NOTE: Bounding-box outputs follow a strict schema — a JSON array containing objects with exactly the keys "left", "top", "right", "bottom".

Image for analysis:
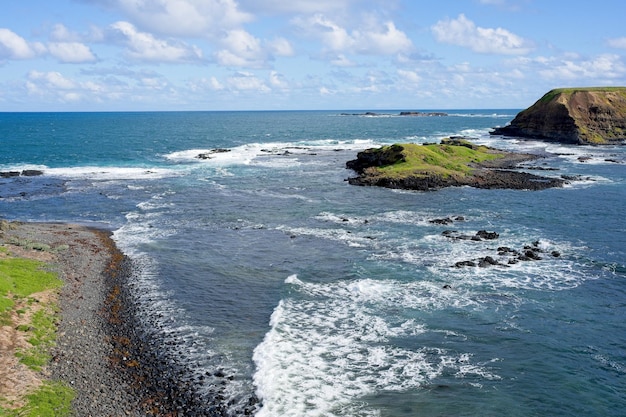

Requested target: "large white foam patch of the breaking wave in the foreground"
[{"left": 253, "top": 275, "right": 498, "bottom": 417}]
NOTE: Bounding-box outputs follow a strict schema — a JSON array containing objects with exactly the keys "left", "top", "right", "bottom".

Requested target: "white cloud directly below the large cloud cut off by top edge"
[{"left": 110, "top": 22, "right": 202, "bottom": 62}]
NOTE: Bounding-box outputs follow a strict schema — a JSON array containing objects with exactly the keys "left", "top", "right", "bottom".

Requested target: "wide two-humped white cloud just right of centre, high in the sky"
[{"left": 293, "top": 13, "right": 413, "bottom": 55}]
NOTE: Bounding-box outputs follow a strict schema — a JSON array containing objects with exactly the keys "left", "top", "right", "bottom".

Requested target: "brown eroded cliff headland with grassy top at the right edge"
[{"left": 492, "top": 87, "right": 626, "bottom": 144}]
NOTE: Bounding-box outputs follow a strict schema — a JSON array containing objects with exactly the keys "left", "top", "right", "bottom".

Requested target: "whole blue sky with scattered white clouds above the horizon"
[{"left": 0, "top": 0, "right": 626, "bottom": 111}]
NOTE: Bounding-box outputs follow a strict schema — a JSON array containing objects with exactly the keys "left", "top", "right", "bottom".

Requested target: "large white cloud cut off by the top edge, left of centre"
[{"left": 114, "top": 0, "right": 252, "bottom": 37}]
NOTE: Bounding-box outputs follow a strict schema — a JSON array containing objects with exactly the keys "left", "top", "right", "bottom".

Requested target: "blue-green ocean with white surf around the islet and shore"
[{"left": 0, "top": 109, "right": 626, "bottom": 417}]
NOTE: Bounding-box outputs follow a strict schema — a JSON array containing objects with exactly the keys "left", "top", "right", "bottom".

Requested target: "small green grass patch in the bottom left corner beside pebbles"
[{"left": 0, "top": 381, "right": 74, "bottom": 417}]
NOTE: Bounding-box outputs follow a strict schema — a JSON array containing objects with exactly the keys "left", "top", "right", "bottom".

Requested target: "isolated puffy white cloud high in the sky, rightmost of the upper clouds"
[{"left": 431, "top": 14, "right": 532, "bottom": 55}]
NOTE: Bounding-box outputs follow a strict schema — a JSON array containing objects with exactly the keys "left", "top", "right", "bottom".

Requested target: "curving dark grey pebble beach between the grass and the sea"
[{"left": 0, "top": 222, "right": 258, "bottom": 416}]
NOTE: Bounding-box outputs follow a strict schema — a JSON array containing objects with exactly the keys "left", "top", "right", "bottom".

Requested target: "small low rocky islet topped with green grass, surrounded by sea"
[{"left": 346, "top": 138, "right": 564, "bottom": 191}]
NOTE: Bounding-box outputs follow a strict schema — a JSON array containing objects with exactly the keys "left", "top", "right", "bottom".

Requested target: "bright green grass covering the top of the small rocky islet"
[{"left": 370, "top": 140, "right": 502, "bottom": 178}]
